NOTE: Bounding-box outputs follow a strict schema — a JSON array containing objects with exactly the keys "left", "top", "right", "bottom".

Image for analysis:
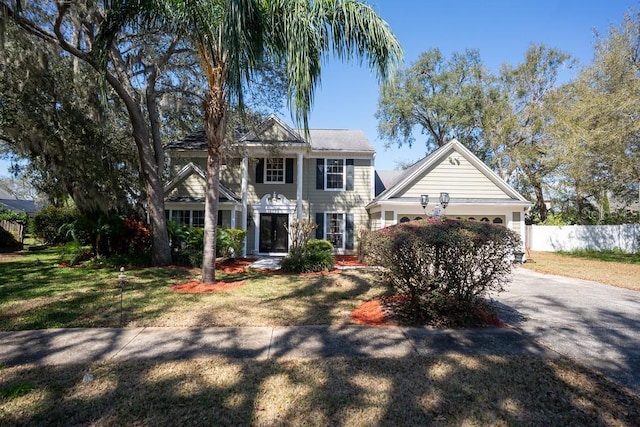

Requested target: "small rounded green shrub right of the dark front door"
[{"left": 280, "top": 239, "right": 335, "bottom": 273}]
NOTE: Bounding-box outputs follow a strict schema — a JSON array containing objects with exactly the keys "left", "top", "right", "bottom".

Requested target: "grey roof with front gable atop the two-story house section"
[{"left": 165, "top": 114, "right": 375, "bottom": 153}]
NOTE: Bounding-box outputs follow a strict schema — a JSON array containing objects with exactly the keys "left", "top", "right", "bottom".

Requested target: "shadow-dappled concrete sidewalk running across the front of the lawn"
[{"left": 0, "top": 325, "right": 555, "bottom": 365}]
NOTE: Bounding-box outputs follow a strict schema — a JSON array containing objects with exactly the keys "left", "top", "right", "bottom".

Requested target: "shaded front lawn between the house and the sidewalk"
[{"left": 0, "top": 250, "right": 387, "bottom": 330}]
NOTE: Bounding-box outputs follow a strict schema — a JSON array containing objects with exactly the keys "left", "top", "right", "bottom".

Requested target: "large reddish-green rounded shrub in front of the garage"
[{"left": 364, "top": 219, "right": 519, "bottom": 324}]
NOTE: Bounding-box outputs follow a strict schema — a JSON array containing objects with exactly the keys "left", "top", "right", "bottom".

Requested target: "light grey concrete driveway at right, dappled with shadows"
[{"left": 494, "top": 268, "right": 640, "bottom": 392}]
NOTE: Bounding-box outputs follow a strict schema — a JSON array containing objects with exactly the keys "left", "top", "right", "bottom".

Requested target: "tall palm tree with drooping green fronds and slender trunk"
[{"left": 99, "top": 0, "right": 402, "bottom": 283}]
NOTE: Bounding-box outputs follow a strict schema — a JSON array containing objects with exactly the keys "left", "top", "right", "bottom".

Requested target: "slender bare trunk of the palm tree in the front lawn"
[{"left": 202, "top": 86, "right": 227, "bottom": 283}]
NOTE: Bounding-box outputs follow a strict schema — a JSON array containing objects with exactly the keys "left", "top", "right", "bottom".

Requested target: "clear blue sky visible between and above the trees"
[{"left": 0, "top": 0, "right": 640, "bottom": 175}]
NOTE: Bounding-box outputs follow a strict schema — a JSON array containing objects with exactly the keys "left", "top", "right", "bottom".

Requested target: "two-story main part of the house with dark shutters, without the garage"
[{"left": 165, "top": 116, "right": 375, "bottom": 255}]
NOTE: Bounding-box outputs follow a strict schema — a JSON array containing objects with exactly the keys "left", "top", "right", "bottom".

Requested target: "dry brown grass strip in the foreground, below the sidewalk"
[{"left": 0, "top": 354, "right": 640, "bottom": 426}]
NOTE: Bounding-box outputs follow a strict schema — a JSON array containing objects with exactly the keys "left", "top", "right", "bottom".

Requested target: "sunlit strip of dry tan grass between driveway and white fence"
[{"left": 523, "top": 252, "right": 640, "bottom": 291}]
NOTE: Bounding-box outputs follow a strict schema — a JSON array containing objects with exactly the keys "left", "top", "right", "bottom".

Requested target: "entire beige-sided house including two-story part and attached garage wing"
[{"left": 165, "top": 115, "right": 530, "bottom": 255}]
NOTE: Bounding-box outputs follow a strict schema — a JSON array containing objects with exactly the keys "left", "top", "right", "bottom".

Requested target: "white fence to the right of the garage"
[{"left": 526, "top": 224, "right": 640, "bottom": 253}]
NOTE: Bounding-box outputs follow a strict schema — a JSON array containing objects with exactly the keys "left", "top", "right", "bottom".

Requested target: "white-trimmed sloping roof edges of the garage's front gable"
[{"left": 368, "top": 139, "right": 529, "bottom": 206}]
